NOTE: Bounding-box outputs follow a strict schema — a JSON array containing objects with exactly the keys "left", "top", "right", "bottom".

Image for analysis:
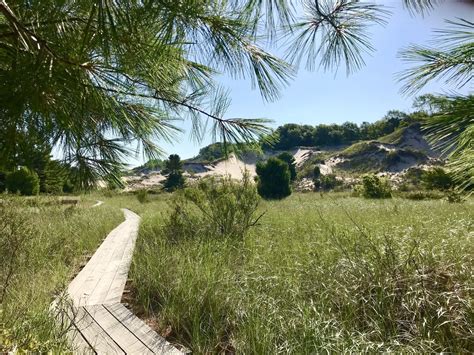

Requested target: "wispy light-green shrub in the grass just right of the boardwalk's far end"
[{"left": 164, "top": 174, "right": 260, "bottom": 241}]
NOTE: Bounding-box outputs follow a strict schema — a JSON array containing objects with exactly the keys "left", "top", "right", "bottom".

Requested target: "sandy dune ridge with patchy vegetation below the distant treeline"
[{"left": 126, "top": 124, "right": 441, "bottom": 190}]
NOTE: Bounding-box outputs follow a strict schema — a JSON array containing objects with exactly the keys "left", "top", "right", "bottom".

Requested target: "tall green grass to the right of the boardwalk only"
[{"left": 131, "top": 194, "right": 474, "bottom": 354}]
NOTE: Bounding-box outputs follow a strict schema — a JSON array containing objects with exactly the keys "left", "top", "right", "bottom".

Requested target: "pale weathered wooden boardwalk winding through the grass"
[{"left": 66, "top": 209, "right": 182, "bottom": 354}]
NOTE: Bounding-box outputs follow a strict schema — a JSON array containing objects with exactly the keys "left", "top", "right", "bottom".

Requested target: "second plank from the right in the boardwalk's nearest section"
[{"left": 85, "top": 305, "right": 153, "bottom": 354}]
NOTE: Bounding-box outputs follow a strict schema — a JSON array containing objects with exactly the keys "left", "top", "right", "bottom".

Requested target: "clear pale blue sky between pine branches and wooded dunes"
[{"left": 130, "top": 0, "right": 474, "bottom": 165}]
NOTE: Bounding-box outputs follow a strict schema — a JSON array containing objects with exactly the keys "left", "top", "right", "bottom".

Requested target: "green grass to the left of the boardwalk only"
[{"left": 0, "top": 196, "right": 123, "bottom": 352}]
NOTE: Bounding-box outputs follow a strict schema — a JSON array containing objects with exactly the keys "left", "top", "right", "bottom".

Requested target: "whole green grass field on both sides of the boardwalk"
[{"left": 0, "top": 193, "right": 474, "bottom": 354}]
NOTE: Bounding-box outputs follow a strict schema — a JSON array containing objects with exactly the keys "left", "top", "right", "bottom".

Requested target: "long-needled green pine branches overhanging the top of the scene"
[{"left": 0, "top": 0, "right": 473, "bottom": 187}]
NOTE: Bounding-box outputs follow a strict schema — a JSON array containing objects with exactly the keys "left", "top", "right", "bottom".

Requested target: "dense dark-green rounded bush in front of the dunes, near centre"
[{"left": 257, "top": 158, "right": 291, "bottom": 199}]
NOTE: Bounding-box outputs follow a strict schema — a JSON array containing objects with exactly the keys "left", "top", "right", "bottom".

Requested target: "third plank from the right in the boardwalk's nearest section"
[{"left": 73, "top": 307, "right": 125, "bottom": 354}]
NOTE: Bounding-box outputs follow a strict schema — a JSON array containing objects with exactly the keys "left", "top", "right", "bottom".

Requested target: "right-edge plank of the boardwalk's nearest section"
[{"left": 104, "top": 303, "right": 183, "bottom": 355}]
